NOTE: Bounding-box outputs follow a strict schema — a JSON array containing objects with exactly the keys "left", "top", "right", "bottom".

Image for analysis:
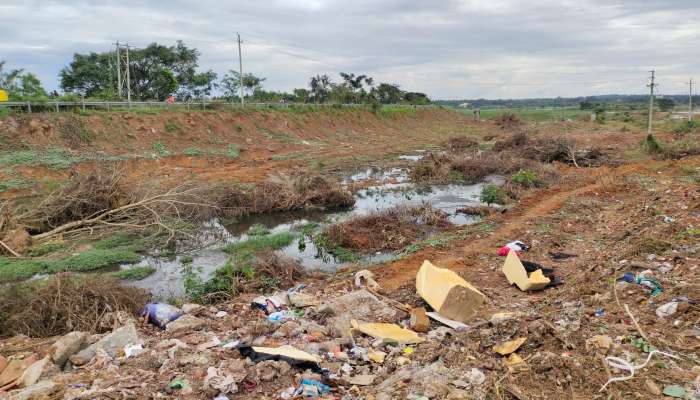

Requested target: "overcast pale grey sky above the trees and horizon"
[{"left": 0, "top": 0, "right": 700, "bottom": 99}]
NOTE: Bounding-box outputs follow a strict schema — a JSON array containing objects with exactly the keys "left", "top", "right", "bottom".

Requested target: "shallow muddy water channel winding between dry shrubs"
[{"left": 120, "top": 159, "right": 501, "bottom": 299}]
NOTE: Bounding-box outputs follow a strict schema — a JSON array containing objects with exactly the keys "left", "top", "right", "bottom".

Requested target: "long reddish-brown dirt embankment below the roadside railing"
[{"left": 0, "top": 108, "right": 466, "bottom": 197}]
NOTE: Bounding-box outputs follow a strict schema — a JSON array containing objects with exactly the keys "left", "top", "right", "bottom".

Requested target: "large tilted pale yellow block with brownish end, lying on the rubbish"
[{"left": 416, "top": 260, "right": 486, "bottom": 322}]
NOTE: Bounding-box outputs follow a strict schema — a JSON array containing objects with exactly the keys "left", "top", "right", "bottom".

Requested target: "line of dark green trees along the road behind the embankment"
[{"left": 0, "top": 41, "right": 430, "bottom": 104}]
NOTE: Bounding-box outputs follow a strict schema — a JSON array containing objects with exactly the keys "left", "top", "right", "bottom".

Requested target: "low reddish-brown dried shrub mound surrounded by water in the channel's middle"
[{"left": 326, "top": 204, "right": 450, "bottom": 253}]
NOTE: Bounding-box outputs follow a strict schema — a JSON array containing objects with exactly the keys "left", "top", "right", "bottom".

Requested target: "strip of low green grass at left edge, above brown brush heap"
[{"left": 0, "top": 235, "right": 145, "bottom": 283}]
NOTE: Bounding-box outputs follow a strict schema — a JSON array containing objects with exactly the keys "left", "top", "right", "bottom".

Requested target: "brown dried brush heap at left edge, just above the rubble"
[{"left": 0, "top": 274, "right": 148, "bottom": 337}]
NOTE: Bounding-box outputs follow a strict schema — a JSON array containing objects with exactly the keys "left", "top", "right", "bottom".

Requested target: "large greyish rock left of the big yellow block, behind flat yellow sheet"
[{"left": 325, "top": 290, "right": 406, "bottom": 336}]
